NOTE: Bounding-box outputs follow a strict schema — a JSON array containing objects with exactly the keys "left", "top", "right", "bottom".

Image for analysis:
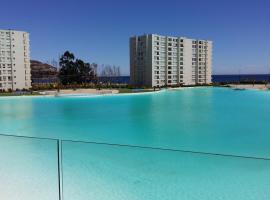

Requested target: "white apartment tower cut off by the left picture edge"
[{"left": 0, "top": 30, "right": 31, "bottom": 90}]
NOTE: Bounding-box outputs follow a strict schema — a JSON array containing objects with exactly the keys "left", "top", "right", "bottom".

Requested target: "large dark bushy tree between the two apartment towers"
[{"left": 59, "top": 51, "right": 96, "bottom": 85}]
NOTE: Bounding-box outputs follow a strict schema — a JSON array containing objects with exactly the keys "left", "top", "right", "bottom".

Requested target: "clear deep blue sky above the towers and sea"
[{"left": 0, "top": 0, "right": 270, "bottom": 74}]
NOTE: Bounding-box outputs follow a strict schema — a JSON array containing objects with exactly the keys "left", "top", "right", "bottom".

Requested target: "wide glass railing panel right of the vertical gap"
[{"left": 62, "top": 142, "right": 270, "bottom": 200}]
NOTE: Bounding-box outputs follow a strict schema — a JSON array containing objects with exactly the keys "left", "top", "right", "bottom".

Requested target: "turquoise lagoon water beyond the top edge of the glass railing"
[{"left": 0, "top": 88, "right": 270, "bottom": 158}]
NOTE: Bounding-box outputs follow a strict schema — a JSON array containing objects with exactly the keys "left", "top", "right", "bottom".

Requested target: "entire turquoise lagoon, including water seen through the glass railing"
[{"left": 0, "top": 88, "right": 270, "bottom": 200}]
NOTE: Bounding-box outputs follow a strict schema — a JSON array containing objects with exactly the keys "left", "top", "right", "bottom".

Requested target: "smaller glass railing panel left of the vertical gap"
[{"left": 0, "top": 136, "right": 59, "bottom": 200}]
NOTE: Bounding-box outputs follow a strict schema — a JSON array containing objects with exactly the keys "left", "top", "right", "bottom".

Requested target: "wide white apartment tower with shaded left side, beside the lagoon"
[{"left": 130, "top": 34, "right": 212, "bottom": 87}]
